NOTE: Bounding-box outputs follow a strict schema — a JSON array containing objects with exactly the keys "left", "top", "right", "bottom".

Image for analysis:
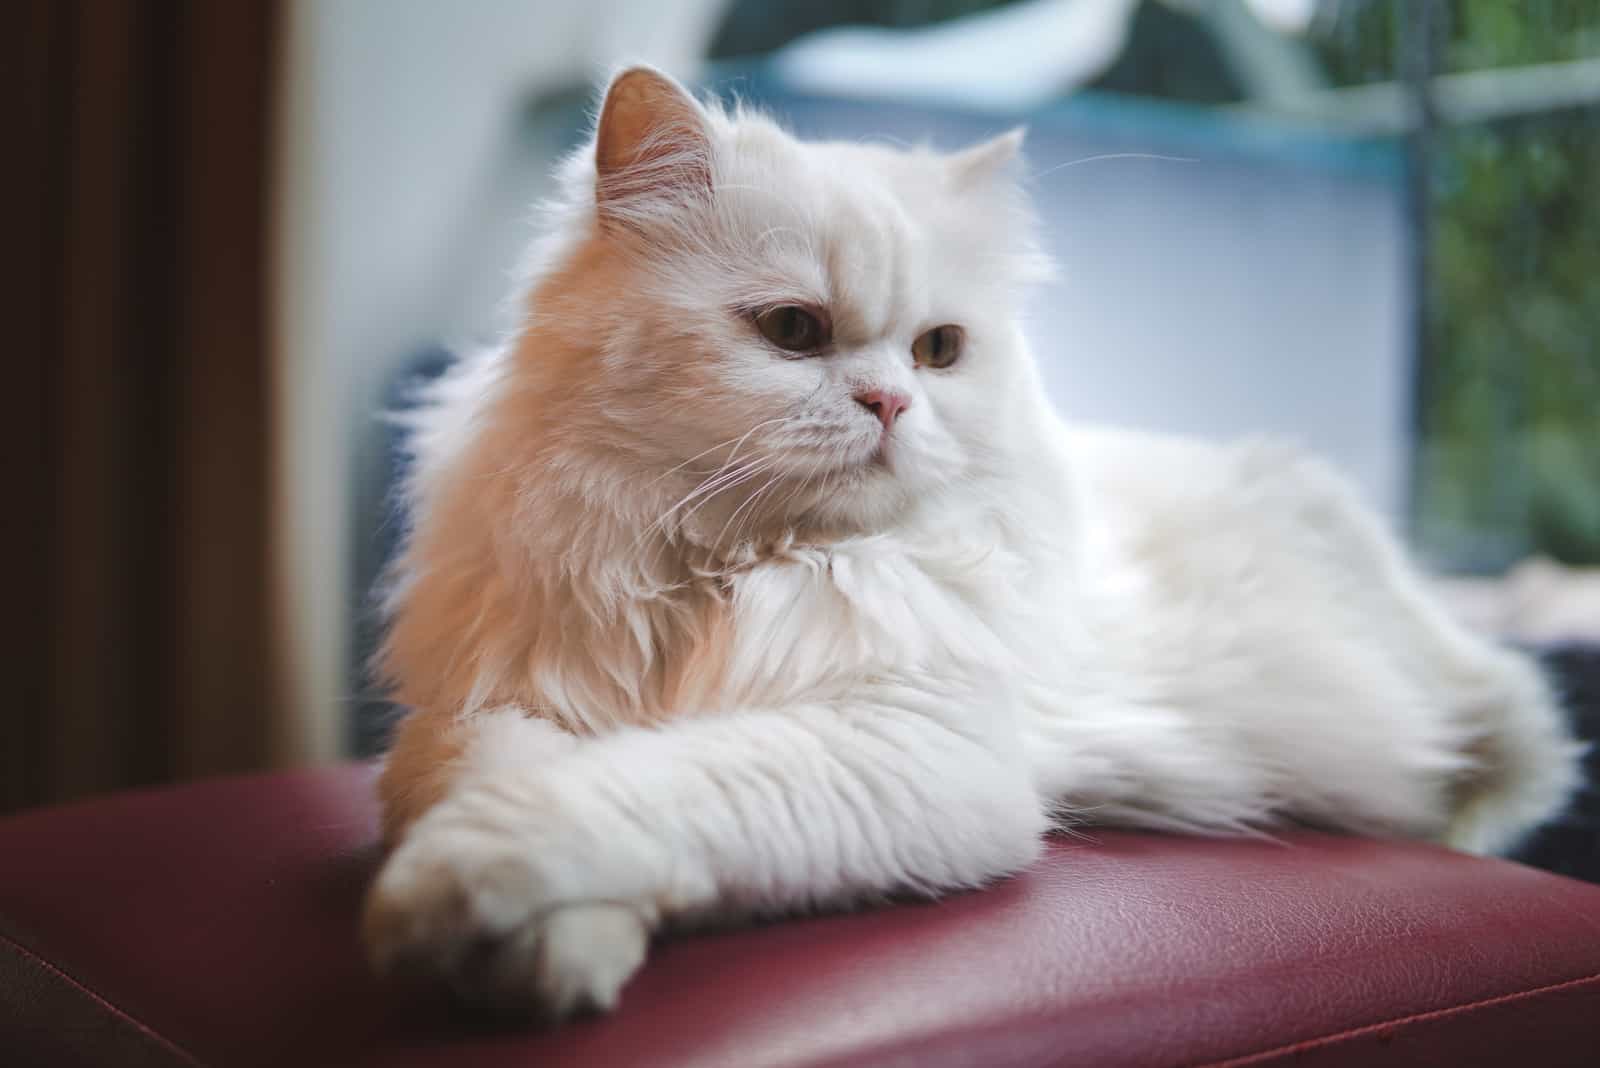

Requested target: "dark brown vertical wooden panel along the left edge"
[{"left": 0, "top": 0, "right": 278, "bottom": 807}]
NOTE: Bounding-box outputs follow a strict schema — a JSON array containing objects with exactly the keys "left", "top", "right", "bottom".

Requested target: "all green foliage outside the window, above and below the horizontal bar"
[{"left": 1317, "top": 0, "right": 1600, "bottom": 569}]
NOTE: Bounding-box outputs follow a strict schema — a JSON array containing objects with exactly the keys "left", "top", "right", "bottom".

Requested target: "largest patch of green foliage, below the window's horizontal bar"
[{"left": 1418, "top": 114, "right": 1600, "bottom": 566}]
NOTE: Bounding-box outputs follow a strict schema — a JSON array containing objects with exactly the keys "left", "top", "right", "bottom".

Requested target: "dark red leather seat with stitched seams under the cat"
[{"left": 0, "top": 767, "right": 1600, "bottom": 1068}]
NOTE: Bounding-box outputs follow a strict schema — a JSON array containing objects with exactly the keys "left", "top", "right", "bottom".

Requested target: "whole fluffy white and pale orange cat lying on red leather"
[{"left": 363, "top": 67, "right": 1579, "bottom": 1017}]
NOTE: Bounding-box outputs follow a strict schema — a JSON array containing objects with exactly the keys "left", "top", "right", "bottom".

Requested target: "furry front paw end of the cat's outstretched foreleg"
[{"left": 363, "top": 803, "right": 654, "bottom": 1018}]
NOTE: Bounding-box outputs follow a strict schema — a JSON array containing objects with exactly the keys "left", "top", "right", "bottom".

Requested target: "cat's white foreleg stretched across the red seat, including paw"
[{"left": 365, "top": 683, "right": 1046, "bottom": 1014}]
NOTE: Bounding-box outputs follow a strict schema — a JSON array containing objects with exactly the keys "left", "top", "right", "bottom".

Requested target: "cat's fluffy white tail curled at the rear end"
[{"left": 1443, "top": 649, "right": 1587, "bottom": 854}]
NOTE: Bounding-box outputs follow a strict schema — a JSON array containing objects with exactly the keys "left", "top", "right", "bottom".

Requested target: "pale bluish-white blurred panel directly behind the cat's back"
[{"left": 1030, "top": 136, "right": 1413, "bottom": 521}]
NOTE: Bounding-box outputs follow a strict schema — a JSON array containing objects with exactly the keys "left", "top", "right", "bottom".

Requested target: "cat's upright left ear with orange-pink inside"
[{"left": 595, "top": 67, "right": 710, "bottom": 214}]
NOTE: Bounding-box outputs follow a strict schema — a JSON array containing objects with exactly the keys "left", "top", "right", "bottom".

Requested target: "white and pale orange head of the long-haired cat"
[{"left": 523, "top": 67, "right": 1048, "bottom": 542}]
